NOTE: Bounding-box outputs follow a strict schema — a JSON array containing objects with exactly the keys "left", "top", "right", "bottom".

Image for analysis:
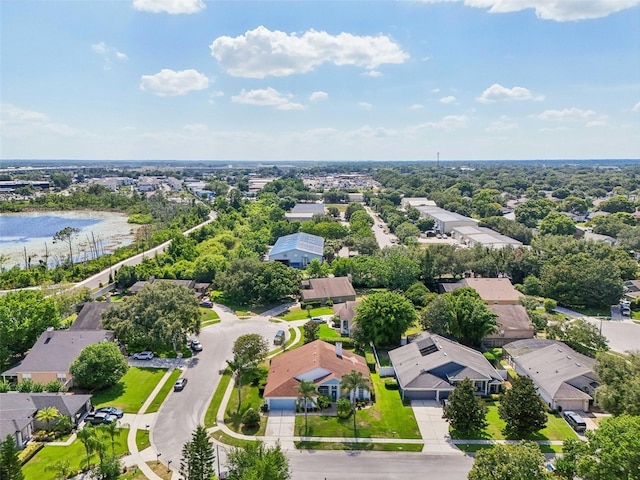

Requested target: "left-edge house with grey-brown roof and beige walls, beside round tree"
[{"left": 2, "top": 328, "right": 114, "bottom": 387}]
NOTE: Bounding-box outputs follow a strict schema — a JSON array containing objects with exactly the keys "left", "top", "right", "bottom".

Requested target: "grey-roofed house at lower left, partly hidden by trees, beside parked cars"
[{"left": 0, "top": 392, "right": 91, "bottom": 448}]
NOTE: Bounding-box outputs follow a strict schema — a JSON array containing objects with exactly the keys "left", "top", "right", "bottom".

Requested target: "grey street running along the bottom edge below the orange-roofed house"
[{"left": 288, "top": 451, "right": 473, "bottom": 480}]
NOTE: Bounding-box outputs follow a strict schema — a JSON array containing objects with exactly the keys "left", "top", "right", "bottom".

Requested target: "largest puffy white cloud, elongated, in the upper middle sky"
[{"left": 209, "top": 26, "right": 409, "bottom": 78}]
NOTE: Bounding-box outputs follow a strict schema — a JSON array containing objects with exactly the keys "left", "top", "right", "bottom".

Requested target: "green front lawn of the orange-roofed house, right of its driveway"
[{"left": 295, "top": 374, "right": 420, "bottom": 438}]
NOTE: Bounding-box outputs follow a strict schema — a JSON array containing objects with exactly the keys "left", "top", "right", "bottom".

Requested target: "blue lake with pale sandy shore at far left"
[{"left": 0, "top": 210, "right": 139, "bottom": 268}]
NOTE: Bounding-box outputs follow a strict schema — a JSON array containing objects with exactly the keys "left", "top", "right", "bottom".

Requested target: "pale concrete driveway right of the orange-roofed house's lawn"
[{"left": 411, "top": 400, "right": 462, "bottom": 455}]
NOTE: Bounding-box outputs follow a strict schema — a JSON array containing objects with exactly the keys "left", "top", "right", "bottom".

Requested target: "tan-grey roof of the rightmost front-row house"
[{"left": 504, "top": 339, "right": 598, "bottom": 400}]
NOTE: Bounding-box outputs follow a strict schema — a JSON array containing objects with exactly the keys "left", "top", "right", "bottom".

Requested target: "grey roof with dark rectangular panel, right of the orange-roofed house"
[{"left": 389, "top": 333, "right": 502, "bottom": 389}]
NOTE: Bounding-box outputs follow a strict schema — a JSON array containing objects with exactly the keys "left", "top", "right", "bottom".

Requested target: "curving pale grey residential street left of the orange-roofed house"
[{"left": 151, "top": 317, "right": 283, "bottom": 469}]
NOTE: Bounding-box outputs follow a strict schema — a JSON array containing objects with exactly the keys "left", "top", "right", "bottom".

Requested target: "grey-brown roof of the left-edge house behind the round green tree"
[{"left": 2, "top": 330, "right": 113, "bottom": 376}]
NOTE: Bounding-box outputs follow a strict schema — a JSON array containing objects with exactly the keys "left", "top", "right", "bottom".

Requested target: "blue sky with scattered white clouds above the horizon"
[{"left": 0, "top": 0, "right": 640, "bottom": 161}]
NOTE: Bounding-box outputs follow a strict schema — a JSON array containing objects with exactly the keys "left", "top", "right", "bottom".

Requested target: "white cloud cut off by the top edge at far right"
[{"left": 412, "top": 0, "right": 640, "bottom": 22}]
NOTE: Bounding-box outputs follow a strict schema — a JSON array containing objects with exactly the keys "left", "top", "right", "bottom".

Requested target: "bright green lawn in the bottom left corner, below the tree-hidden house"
[{"left": 22, "top": 428, "right": 129, "bottom": 480}]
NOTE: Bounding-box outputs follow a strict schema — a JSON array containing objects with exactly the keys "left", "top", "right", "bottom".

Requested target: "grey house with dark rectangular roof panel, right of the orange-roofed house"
[{"left": 389, "top": 332, "right": 503, "bottom": 401}]
